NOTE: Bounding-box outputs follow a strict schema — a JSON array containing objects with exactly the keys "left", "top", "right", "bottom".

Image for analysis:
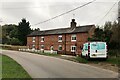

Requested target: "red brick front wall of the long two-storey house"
[{"left": 27, "top": 33, "right": 89, "bottom": 54}]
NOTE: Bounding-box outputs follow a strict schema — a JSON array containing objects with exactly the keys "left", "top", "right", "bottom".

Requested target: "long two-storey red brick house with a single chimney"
[{"left": 27, "top": 19, "right": 95, "bottom": 55}]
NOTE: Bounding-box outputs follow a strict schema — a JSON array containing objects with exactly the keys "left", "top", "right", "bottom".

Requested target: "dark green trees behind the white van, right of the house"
[{"left": 88, "top": 22, "right": 120, "bottom": 49}]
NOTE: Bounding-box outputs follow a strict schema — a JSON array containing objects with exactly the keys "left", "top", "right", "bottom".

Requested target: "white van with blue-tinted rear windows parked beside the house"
[{"left": 81, "top": 42, "right": 108, "bottom": 59}]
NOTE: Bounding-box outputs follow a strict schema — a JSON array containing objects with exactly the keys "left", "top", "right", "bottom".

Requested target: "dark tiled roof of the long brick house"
[{"left": 28, "top": 25, "right": 94, "bottom": 36}]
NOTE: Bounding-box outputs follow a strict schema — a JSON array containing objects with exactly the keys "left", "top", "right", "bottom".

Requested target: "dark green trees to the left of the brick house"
[{"left": 2, "top": 19, "right": 32, "bottom": 45}]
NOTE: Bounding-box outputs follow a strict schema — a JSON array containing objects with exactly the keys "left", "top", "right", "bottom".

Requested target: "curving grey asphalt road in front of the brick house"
[{"left": 2, "top": 50, "right": 118, "bottom": 78}]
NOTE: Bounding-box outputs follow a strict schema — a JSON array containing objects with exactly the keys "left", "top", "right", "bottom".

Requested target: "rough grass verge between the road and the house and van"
[{"left": 29, "top": 51, "right": 120, "bottom": 72}]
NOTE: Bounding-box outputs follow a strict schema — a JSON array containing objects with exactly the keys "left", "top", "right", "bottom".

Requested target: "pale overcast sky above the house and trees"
[{"left": 0, "top": 0, "right": 118, "bottom": 30}]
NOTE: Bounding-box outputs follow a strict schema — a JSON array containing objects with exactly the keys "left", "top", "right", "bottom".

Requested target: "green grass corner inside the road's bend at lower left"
[{"left": 2, "top": 55, "right": 32, "bottom": 80}]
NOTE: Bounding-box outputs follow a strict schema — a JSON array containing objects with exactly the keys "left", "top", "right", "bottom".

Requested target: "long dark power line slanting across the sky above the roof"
[{"left": 32, "top": 0, "right": 96, "bottom": 26}]
